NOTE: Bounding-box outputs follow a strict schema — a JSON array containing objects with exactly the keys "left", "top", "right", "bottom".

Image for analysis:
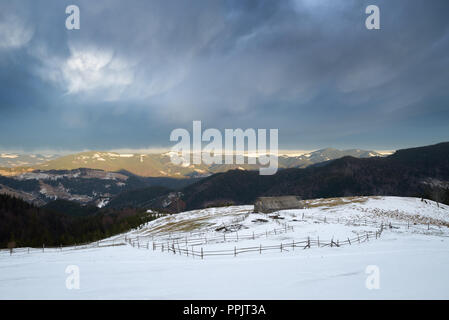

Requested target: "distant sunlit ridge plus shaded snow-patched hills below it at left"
[{"left": 0, "top": 148, "right": 380, "bottom": 207}]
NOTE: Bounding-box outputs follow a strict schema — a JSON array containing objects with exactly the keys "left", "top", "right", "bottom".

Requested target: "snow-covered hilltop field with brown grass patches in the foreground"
[{"left": 0, "top": 197, "right": 449, "bottom": 299}]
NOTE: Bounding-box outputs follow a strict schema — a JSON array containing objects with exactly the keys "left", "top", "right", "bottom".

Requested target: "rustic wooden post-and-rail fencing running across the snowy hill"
[{"left": 5, "top": 215, "right": 448, "bottom": 257}]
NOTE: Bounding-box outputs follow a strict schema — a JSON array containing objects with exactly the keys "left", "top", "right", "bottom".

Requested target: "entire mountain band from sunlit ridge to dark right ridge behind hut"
[{"left": 0, "top": 143, "right": 449, "bottom": 212}]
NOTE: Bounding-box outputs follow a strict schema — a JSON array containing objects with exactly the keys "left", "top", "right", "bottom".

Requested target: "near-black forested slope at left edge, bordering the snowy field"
[{"left": 0, "top": 195, "right": 158, "bottom": 248}]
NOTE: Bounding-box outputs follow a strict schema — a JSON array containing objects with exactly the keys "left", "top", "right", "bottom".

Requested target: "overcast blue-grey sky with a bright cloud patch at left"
[{"left": 0, "top": 0, "right": 449, "bottom": 152}]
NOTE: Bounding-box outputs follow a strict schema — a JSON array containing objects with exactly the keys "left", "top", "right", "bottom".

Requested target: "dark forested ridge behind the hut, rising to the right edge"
[{"left": 178, "top": 142, "right": 449, "bottom": 210}]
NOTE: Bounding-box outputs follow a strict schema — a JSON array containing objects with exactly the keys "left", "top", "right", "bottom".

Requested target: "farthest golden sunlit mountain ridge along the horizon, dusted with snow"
[{"left": 0, "top": 148, "right": 382, "bottom": 178}]
